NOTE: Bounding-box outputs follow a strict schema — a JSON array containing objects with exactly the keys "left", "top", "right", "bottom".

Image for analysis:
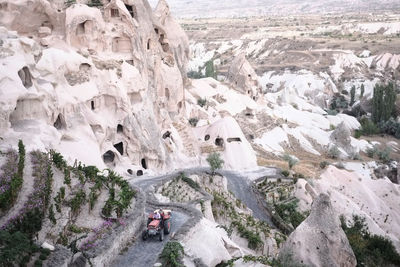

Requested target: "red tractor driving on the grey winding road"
[{"left": 142, "top": 210, "right": 171, "bottom": 241}]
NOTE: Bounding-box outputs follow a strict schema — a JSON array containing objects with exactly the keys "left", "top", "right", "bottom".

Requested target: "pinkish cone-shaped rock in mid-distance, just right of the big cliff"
[{"left": 228, "top": 53, "right": 261, "bottom": 100}]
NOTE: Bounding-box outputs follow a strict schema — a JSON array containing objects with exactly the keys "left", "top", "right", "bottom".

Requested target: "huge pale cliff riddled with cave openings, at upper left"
[{"left": 0, "top": 0, "right": 189, "bottom": 172}]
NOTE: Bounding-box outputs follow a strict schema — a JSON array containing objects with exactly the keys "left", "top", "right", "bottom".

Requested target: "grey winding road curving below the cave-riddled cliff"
[{"left": 113, "top": 167, "right": 278, "bottom": 267}]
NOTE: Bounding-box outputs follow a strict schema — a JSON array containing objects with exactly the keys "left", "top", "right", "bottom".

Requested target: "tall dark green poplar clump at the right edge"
[{"left": 372, "top": 83, "right": 396, "bottom": 123}]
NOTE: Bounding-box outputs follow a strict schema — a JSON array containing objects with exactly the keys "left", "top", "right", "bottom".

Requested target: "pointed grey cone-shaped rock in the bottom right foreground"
[{"left": 279, "top": 194, "right": 357, "bottom": 267}]
